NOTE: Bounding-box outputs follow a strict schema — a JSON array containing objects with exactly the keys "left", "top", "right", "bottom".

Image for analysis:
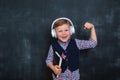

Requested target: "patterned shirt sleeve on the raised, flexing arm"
[{"left": 75, "top": 38, "right": 97, "bottom": 50}]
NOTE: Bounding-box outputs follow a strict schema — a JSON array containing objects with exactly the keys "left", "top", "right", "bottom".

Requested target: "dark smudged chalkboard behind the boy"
[{"left": 0, "top": 0, "right": 120, "bottom": 80}]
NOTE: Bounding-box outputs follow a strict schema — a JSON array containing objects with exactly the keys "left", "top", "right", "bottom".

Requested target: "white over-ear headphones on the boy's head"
[{"left": 51, "top": 17, "right": 75, "bottom": 38}]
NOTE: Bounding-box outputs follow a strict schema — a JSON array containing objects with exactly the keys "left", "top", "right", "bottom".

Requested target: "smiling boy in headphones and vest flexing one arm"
[{"left": 46, "top": 17, "right": 97, "bottom": 80}]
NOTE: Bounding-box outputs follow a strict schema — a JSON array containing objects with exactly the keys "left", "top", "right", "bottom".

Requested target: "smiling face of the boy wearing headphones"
[{"left": 55, "top": 24, "right": 71, "bottom": 42}]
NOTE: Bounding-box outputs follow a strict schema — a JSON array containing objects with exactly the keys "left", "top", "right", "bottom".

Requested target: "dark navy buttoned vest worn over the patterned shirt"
[{"left": 52, "top": 39, "right": 79, "bottom": 72}]
